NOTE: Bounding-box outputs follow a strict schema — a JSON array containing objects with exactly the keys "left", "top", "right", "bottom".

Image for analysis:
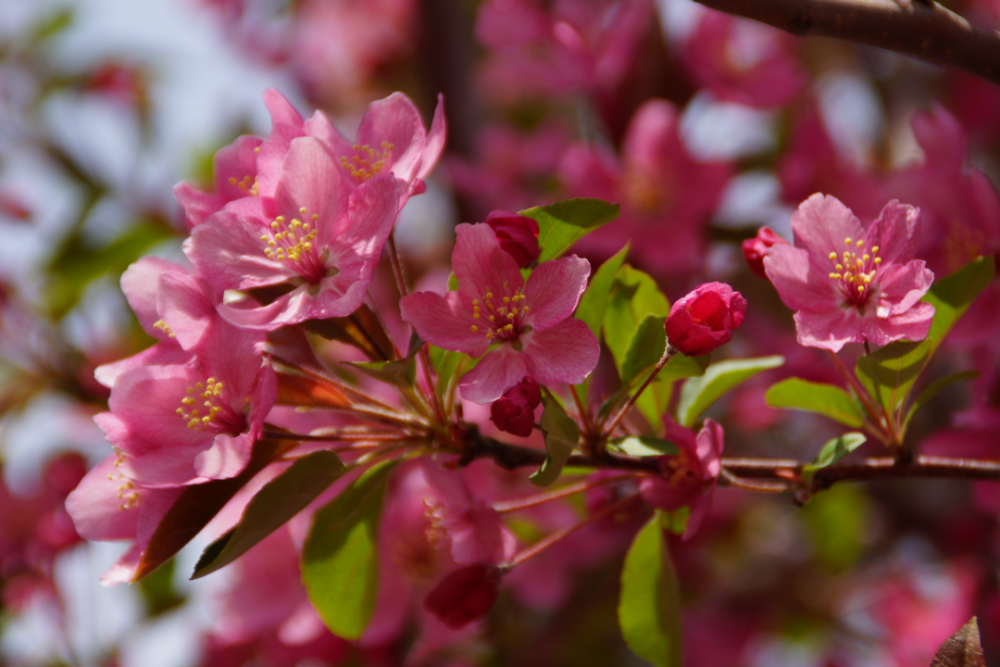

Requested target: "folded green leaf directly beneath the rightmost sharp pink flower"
[{"left": 854, "top": 338, "right": 935, "bottom": 414}]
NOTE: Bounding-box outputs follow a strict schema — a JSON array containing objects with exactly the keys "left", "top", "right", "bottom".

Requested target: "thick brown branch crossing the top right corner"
[{"left": 697, "top": 0, "right": 1000, "bottom": 84}]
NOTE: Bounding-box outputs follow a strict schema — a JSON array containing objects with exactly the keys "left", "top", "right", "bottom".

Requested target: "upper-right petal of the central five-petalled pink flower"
[{"left": 524, "top": 255, "right": 590, "bottom": 330}]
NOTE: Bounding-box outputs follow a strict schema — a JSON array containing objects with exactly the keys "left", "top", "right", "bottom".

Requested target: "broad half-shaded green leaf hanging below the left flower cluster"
[{"left": 302, "top": 461, "right": 397, "bottom": 639}]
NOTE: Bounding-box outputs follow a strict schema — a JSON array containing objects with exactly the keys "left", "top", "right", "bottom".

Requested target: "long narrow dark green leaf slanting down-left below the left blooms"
[{"left": 191, "top": 450, "right": 344, "bottom": 579}]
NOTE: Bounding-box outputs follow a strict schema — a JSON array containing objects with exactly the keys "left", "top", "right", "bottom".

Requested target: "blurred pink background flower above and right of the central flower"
[{"left": 559, "top": 100, "right": 732, "bottom": 275}]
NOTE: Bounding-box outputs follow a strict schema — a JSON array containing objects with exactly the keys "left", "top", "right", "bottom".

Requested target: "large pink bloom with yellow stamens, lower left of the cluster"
[{"left": 94, "top": 320, "right": 277, "bottom": 487}]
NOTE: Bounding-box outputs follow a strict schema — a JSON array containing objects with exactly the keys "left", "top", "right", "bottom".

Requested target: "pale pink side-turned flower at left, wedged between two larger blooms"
[{"left": 94, "top": 257, "right": 217, "bottom": 388}]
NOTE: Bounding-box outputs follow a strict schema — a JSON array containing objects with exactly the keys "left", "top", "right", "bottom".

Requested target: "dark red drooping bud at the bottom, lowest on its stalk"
[{"left": 424, "top": 565, "right": 500, "bottom": 630}]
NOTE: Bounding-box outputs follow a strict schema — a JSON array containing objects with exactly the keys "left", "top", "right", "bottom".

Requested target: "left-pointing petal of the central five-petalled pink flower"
[{"left": 399, "top": 292, "right": 490, "bottom": 358}]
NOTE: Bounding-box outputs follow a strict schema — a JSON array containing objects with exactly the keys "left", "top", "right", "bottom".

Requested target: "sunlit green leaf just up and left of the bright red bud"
[{"left": 602, "top": 264, "right": 670, "bottom": 374}]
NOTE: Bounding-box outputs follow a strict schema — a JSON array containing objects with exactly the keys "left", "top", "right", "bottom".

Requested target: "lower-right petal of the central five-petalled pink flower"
[{"left": 520, "top": 318, "right": 601, "bottom": 386}]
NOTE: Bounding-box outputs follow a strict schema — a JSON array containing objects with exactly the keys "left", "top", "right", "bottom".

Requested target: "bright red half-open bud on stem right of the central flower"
[{"left": 666, "top": 283, "right": 747, "bottom": 357}]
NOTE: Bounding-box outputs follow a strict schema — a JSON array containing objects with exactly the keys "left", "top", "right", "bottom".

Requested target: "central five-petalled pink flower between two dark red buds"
[{"left": 399, "top": 223, "right": 600, "bottom": 404}]
